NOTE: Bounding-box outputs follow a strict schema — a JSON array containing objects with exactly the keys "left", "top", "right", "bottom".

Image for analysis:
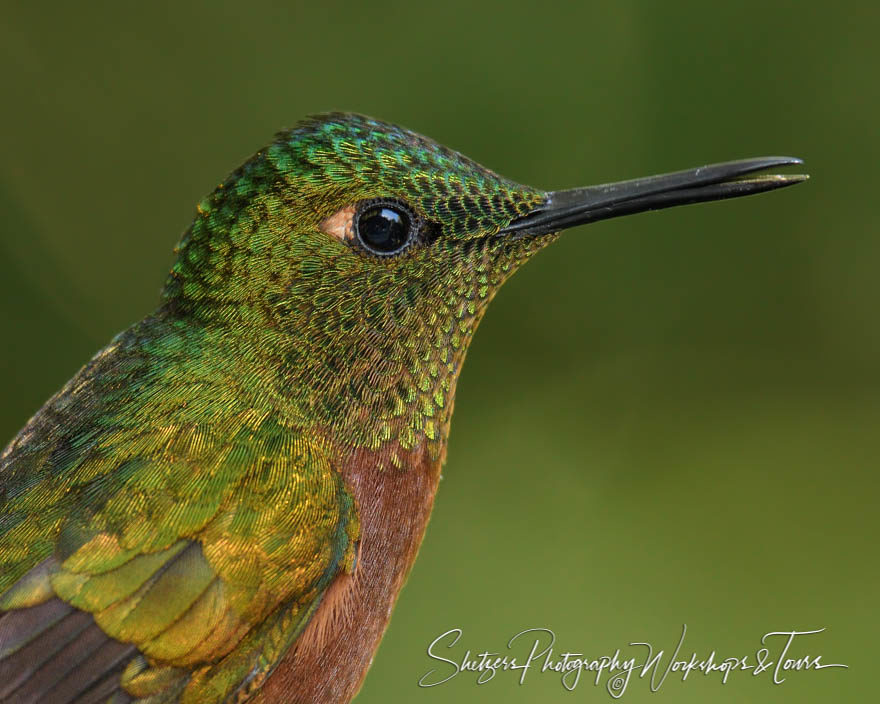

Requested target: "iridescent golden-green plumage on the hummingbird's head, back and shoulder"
[{"left": 0, "top": 115, "right": 552, "bottom": 704}]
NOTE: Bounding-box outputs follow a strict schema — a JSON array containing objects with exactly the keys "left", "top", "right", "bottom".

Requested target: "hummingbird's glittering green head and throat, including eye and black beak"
[{"left": 163, "top": 113, "right": 802, "bottom": 464}]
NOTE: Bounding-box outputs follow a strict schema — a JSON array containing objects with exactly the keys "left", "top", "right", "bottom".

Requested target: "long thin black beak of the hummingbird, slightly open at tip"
[{"left": 501, "top": 156, "right": 808, "bottom": 237}]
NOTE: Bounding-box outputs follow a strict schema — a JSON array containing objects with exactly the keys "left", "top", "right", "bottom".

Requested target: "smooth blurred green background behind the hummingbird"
[{"left": 0, "top": 0, "right": 880, "bottom": 704}]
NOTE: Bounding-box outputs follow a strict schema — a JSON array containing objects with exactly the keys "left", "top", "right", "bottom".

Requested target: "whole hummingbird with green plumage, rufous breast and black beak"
[{"left": 0, "top": 113, "right": 806, "bottom": 704}]
